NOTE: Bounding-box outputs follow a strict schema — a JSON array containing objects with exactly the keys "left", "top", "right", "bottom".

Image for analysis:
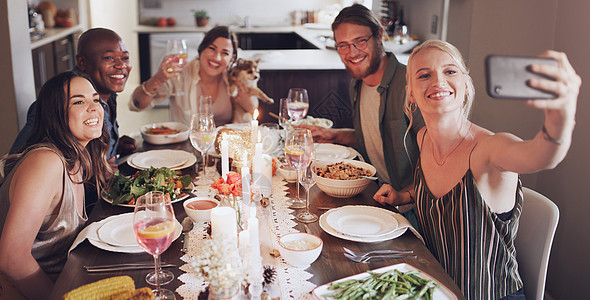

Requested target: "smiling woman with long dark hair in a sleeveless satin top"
[{"left": 0, "top": 72, "right": 110, "bottom": 299}]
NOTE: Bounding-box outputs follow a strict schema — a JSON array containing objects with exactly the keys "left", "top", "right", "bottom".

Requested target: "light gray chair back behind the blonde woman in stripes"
[{"left": 515, "top": 187, "right": 559, "bottom": 300}]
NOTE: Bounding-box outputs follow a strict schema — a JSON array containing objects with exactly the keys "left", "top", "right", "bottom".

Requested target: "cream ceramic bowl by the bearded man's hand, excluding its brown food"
[{"left": 316, "top": 159, "right": 377, "bottom": 198}]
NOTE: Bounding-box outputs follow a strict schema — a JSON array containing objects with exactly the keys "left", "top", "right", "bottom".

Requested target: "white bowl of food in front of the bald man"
[{"left": 139, "top": 122, "right": 190, "bottom": 145}]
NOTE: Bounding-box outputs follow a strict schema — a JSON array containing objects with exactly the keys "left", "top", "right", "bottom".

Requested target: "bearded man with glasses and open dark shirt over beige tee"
[{"left": 306, "top": 4, "right": 424, "bottom": 224}]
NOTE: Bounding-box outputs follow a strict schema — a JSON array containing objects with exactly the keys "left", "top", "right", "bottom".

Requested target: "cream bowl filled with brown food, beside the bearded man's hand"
[{"left": 316, "top": 159, "right": 377, "bottom": 198}]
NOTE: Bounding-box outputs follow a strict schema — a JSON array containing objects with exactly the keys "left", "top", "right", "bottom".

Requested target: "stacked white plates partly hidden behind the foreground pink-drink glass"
[{"left": 88, "top": 213, "right": 182, "bottom": 253}]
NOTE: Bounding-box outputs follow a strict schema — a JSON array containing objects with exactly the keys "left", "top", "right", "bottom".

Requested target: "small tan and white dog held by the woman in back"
[{"left": 228, "top": 58, "right": 274, "bottom": 123}]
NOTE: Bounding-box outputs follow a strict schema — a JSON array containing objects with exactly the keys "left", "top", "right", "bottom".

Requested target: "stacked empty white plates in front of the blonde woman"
[{"left": 320, "top": 205, "right": 407, "bottom": 243}]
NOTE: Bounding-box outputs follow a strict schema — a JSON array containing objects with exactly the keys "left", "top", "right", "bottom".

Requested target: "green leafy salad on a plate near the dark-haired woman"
[{"left": 103, "top": 167, "right": 192, "bottom": 205}]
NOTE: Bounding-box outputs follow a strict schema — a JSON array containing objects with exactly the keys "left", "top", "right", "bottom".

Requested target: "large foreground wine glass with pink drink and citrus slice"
[{"left": 133, "top": 191, "right": 176, "bottom": 299}]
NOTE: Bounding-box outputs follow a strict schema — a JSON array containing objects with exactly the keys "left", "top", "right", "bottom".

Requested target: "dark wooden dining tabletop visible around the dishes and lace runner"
[{"left": 49, "top": 141, "right": 464, "bottom": 299}]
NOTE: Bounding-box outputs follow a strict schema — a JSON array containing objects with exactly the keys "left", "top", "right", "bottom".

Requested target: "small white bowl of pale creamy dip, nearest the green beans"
[{"left": 279, "top": 232, "right": 324, "bottom": 268}]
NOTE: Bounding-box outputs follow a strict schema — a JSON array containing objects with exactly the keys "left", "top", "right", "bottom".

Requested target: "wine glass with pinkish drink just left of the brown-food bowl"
[{"left": 285, "top": 128, "right": 313, "bottom": 208}]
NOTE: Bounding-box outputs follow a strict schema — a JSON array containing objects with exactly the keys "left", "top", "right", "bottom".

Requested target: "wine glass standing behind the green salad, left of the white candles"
[{"left": 190, "top": 113, "right": 216, "bottom": 180}]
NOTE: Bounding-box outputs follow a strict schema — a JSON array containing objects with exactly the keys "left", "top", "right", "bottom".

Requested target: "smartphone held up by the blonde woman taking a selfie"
[{"left": 485, "top": 55, "right": 557, "bottom": 99}]
